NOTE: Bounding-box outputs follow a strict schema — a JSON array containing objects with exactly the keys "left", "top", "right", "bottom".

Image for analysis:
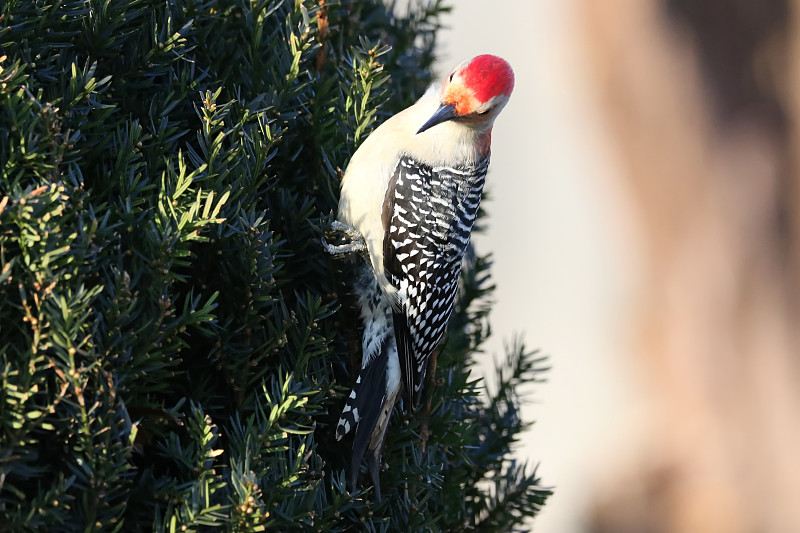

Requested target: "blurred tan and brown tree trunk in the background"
[{"left": 582, "top": 0, "right": 800, "bottom": 533}]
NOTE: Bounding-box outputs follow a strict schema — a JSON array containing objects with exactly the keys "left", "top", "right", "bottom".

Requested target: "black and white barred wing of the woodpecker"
[{"left": 383, "top": 156, "right": 489, "bottom": 409}]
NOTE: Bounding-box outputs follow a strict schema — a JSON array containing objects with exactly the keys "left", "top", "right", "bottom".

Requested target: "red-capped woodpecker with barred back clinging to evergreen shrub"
[{"left": 325, "top": 55, "right": 514, "bottom": 499}]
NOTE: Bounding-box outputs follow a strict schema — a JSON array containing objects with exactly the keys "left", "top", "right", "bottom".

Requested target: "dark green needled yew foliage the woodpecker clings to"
[{"left": 0, "top": 0, "right": 548, "bottom": 531}]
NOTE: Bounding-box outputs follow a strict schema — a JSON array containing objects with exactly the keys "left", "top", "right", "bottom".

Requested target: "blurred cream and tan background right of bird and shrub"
[{"left": 439, "top": 0, "right": 800, "bottom": 533}]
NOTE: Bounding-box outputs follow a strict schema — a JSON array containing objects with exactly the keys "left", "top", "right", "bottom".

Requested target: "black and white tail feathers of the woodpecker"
[{"left": 336, "top": 265, "right": 400, "bottom": 500}]
